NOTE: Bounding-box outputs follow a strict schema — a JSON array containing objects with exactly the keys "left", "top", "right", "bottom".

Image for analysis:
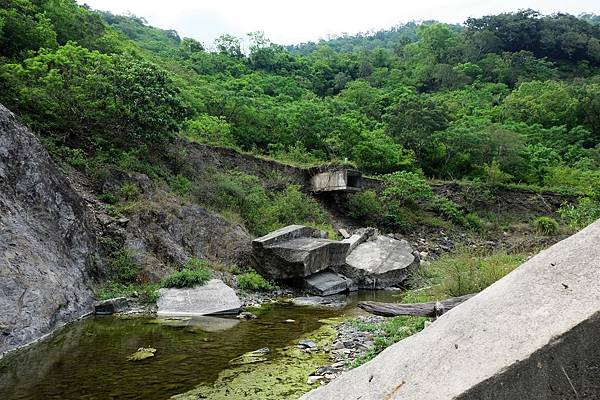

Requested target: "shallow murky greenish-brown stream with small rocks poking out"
[{"left": 0, "top": 291, "right": 400, "bottom": 400}]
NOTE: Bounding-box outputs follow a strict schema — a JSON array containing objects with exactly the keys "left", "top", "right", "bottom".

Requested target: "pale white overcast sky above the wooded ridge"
[{"left": 79, "top": 0, "right": 600, "bottom": 45}]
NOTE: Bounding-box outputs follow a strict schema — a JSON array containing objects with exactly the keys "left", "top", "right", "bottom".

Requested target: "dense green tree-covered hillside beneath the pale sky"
[{"left": 0, "top": 0, "right": 600, "bottom": 230}]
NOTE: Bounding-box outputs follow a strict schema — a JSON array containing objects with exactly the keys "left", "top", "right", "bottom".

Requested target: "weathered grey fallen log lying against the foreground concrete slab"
[{"left": 358, "top": 293, "right": 477, "bottom": 317}]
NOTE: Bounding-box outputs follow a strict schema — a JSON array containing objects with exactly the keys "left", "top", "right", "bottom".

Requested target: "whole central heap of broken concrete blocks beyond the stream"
[{"left": 252, "top": 225, "right": 419, "bottom": 296}]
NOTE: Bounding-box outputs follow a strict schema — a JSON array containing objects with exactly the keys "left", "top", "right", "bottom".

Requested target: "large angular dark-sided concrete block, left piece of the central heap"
[{"left": 252, "top": 225, "right": 349, "bottom": 279}]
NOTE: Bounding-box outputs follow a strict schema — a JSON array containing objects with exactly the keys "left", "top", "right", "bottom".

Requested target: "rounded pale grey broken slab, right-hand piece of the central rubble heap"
[{"left": 334, "top": 232, "right": 419, "bottom": 289}]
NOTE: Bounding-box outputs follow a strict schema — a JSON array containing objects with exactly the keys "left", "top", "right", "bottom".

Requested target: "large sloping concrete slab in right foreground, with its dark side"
[{"left": 302, "top": 221, "right": 600, "bottom": 400}]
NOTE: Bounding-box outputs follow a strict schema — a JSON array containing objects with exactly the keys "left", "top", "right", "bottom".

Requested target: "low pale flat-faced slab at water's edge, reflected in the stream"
[{"left": 156, "top": 279, "right": 242, "bottom": 317}]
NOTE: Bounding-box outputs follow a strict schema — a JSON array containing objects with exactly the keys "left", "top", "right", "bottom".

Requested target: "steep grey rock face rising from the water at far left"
[{"left": 0, "top": 105, "right": 97, "bottom": 353}]
